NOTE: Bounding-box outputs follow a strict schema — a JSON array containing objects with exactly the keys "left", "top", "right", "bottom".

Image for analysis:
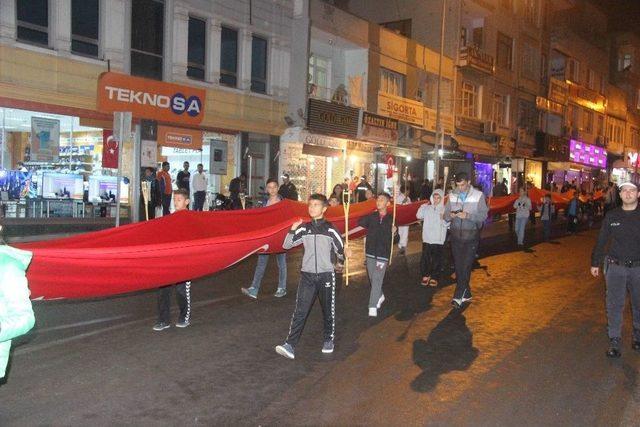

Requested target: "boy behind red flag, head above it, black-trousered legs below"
[{"left": 153, "top": 188, "right": 191, "bottom": 331}]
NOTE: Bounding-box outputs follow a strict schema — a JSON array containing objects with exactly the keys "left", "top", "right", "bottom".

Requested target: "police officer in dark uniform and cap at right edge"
[{"left": 591, "top": 182, "right": 640, "bottom": 357}]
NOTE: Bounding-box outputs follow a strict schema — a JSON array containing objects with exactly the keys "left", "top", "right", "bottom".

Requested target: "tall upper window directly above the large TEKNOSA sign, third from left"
[{"left": 131, "top": 0, "right": 164, "bottom": 80}]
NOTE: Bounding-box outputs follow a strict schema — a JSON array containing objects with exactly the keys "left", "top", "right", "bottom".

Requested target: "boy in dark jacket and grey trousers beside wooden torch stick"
[{"left": 358, "top": 193, "right": 398, "bottom": 317}]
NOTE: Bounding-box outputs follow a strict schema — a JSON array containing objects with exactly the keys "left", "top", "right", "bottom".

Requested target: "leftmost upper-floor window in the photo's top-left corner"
[{"left": 16, "top": 0, "right": 49, "bottom": 46}]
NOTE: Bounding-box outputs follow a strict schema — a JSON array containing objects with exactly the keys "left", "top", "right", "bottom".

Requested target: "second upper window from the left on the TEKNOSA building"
[{"left": 71, "top": 0, "right": 100, "bottom": 57}]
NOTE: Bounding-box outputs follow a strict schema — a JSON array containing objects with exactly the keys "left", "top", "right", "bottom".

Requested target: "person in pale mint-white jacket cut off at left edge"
[{"left": 0, "top": 237, "right": 35, "bottom": 379}]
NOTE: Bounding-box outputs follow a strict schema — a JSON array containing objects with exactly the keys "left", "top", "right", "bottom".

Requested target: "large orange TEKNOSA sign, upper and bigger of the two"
[{"left": 98, "top": 72, "right": 206, "bottom": 125}]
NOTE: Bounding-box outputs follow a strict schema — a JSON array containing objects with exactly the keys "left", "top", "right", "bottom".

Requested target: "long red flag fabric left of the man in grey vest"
[{"left": 16, "top": 200, "right": 421, "bottom": 299}]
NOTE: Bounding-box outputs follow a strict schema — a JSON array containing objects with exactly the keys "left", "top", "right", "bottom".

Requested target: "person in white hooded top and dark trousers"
[{"left": 416, "top": 189, "right": 448, "bottom": 286}]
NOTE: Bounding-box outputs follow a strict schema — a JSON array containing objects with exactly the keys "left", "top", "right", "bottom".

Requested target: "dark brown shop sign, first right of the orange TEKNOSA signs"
[{"left": 307, "top": 99, "right": 360, "bottom": 138}]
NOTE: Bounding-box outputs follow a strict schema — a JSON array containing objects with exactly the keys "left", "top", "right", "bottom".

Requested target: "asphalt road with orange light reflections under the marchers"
[{"left": 0, "top": 222, "right": 640, "bottom": 426}]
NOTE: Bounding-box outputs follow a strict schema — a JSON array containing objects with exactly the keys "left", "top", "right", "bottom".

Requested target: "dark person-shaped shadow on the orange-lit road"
[{"left": 411, "top": 309, "right": 480, "bottom": 393}]
